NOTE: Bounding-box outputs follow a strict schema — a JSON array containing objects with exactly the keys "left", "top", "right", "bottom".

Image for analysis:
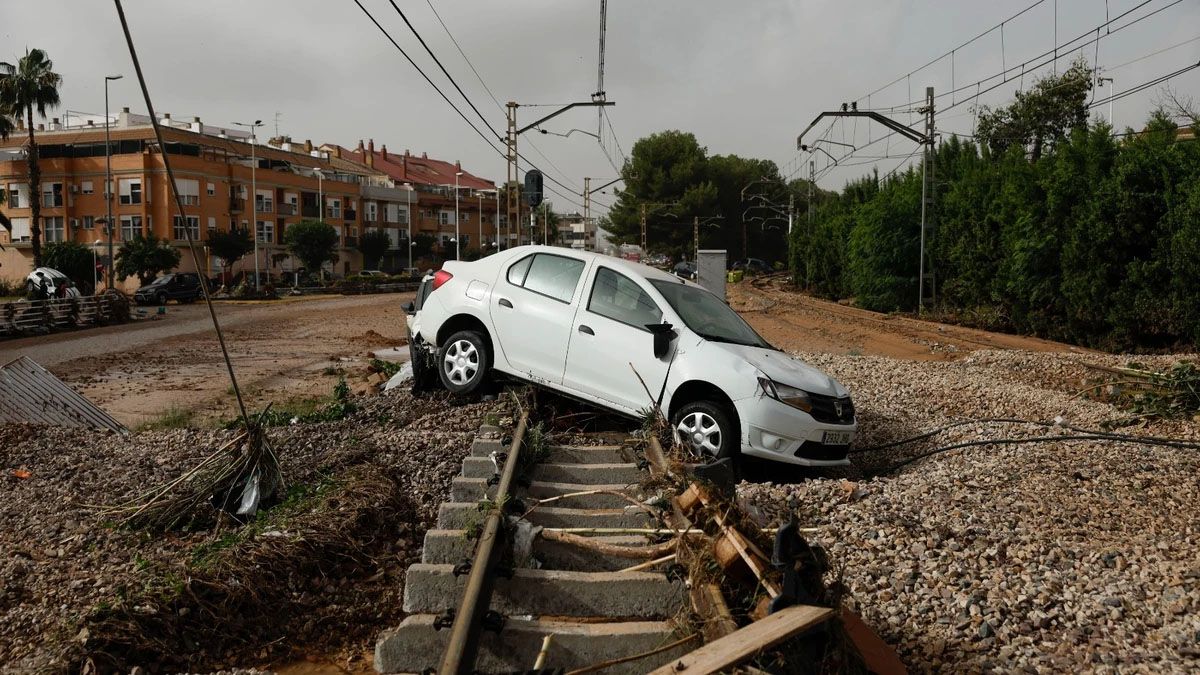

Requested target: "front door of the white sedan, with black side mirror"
[{"left": 563, "top": 263, "right": 670, "bottom": 414}]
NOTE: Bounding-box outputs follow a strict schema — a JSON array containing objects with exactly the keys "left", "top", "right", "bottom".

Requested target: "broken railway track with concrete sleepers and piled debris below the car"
[{"left": 374, "top": 403, "right": 892, "bottom": 675}]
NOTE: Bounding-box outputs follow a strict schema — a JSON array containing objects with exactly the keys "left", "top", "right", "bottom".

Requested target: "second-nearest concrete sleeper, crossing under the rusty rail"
[{"left": 404, "top": 563, "right": 686, "bottom": 619}]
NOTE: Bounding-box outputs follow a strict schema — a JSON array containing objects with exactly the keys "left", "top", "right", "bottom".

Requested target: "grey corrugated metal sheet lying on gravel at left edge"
[{"left": 0, "top": 357, "right": 126, "bottom": 432}]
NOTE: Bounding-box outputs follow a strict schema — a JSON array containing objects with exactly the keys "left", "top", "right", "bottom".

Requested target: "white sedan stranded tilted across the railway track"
[{"left": 413, "top": 246, "right": 858, "bottom": 466}]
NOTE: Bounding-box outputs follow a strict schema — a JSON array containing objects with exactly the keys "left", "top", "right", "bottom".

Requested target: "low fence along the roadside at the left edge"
[{"left": 0, "top": 293, "right": 130, "bottom": 338}]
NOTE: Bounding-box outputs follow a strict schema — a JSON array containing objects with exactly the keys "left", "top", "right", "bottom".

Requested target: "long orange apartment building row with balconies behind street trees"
[{"left": 0, "top": 108, "right": 516, "bottom": 289}]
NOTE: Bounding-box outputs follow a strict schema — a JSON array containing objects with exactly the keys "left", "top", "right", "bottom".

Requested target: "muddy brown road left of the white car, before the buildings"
[{"left": 0, "top": 294, "right": 410, "bottom": 426}]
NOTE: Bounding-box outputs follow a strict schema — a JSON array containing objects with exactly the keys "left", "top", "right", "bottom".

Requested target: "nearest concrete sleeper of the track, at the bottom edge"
[{"left": 374, "top": 614, "right": 695, "bottom": 675}]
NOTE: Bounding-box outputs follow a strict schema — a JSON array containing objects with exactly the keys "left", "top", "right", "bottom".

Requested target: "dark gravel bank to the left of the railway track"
[{"left": 0, "top": 390, "right": 505, "bottom": 674}]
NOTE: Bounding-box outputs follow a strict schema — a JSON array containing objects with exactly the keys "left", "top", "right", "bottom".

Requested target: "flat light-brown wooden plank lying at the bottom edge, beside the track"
[{"left": 650, "top": 605, "right": 834, "bottom": 675}]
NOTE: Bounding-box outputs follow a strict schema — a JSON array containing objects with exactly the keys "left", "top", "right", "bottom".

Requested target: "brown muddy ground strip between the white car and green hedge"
[{"left": 727, "top": 273, "right": 1088, "bottom": 360}]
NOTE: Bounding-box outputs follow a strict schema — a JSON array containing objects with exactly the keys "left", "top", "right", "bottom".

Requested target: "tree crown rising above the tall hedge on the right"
[{"left": 976, "top": 59, "right": 1096, "bottom": 162}]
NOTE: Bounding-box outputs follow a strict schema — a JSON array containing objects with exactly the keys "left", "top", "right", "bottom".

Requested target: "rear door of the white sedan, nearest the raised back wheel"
[{"left": 490, "top": 252, "right": 587, "bottom": 384}]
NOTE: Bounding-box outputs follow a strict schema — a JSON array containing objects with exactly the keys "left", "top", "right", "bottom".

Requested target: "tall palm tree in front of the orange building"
[{"left": 0, "top": 49, "right": 62, "bottom": 267}]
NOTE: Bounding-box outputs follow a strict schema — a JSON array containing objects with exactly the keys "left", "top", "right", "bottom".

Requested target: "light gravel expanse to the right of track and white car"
[{"left": 739, "top": 352, "right": 1200, "bottom": 673}]
